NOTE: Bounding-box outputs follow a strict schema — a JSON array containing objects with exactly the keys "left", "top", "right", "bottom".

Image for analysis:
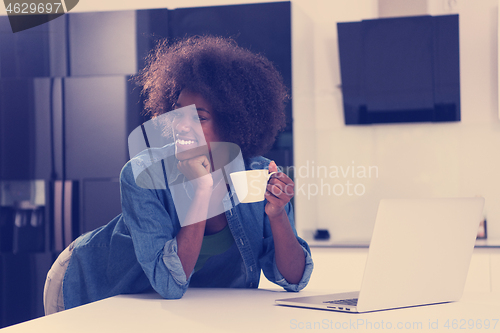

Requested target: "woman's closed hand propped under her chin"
[{"left": 177, "top": 155, "right": 214, "bottom": 190}]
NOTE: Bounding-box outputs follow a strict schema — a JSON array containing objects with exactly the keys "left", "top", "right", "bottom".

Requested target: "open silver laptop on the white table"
[{"left": 276, "top": 197, "right": 484, "bottom": 313}]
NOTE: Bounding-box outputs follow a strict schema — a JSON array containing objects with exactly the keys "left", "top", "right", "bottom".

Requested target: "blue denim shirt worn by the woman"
[{"left": 63, "top": 144, "right": 313, "bottom": 309}]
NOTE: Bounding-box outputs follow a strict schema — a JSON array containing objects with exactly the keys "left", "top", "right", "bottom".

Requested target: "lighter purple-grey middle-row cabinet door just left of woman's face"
[{"left": 64, "top": 76, "right": 128, "bottom": 179}]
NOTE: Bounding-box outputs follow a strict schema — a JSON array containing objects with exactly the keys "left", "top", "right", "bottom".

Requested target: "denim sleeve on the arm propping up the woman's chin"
[{"left": 120, "top": 162, "right": 189, "bottom": 299}]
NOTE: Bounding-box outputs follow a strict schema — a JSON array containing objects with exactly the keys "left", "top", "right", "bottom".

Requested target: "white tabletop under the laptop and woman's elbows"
[{"left": 1, "top": 288, "right": 500, "bottom": 333}]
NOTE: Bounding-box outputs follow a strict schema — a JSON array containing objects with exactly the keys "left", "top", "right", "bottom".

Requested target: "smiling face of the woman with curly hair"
[{"left": 171, "top": 90, "right": 221, "bottom": 160}]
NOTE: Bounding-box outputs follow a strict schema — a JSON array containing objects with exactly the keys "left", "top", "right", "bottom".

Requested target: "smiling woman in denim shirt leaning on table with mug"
[{"left": 44, "top": 37, "right": 313, "bottom": 314}]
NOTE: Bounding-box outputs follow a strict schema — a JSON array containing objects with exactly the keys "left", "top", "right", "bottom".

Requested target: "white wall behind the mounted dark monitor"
[{"left": 0, "top": 0, "right": 500, "bottom": 239}]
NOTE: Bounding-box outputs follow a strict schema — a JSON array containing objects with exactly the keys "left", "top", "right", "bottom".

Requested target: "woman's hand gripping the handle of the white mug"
[{"left": 265, "top": 161, "right": 295, "bottom": 218}]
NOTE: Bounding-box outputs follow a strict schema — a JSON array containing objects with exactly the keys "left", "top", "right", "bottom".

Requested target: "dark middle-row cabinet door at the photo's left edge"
[{"left": 0, "top": 78, "right": 62, "bottom": 180}]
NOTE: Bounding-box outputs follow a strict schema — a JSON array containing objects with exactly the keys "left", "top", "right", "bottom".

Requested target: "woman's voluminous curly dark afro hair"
[{"left": 135, "top": 36, "right": 288, "bottom": 157}]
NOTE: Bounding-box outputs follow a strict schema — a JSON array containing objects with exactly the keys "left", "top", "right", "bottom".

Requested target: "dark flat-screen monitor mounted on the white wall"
[{"left": 337, "top": 15, "right": 460, "bottom": 125}]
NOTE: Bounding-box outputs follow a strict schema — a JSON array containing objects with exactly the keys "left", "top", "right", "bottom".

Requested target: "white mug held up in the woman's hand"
[{"left": 230, "top": 170, "right": 276, "bottom": 203}]
